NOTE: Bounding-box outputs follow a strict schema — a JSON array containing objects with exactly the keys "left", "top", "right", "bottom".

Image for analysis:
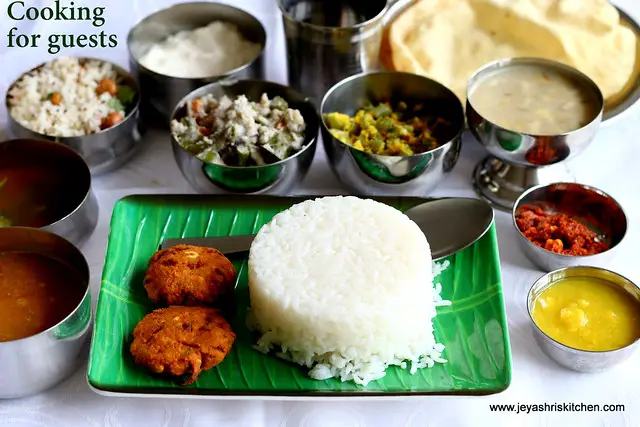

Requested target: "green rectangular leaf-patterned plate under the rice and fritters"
[{"left": 88, "top": 195, "right": 511, "bottom": 398}]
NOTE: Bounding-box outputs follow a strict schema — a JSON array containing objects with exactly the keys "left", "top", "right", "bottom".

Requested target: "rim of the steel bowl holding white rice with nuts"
[{"left": 5, "top": 56, "right": 141, "bottom": 143}]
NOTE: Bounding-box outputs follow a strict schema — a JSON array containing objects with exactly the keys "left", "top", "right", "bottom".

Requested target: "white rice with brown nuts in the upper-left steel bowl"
[{"left": 8, "top": 57, "right": 124, "bottom": 137}]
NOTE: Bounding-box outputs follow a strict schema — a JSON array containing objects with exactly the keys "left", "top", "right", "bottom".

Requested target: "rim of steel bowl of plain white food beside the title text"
[{"left": 127, "top": 1, "right": 267, "bottom": 82}]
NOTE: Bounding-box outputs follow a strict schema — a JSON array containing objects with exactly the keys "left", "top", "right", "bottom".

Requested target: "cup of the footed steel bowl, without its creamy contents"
[{"left": 466, "top": 58, "right": 604, "bottom": 167}]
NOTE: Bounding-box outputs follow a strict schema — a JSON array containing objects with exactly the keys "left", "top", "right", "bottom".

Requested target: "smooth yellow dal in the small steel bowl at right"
[{"left": 532, "top": 277, "right": 640, "bottom": 351}]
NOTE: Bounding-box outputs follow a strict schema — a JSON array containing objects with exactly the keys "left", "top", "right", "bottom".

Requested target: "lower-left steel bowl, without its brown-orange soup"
[{"left": 0, "top": 227, "right": 91, "bottom": 399}]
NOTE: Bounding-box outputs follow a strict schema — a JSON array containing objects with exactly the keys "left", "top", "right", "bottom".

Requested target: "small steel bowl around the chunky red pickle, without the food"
[{"left": 511, "top": 182, "right": 627, "bottom": 271}]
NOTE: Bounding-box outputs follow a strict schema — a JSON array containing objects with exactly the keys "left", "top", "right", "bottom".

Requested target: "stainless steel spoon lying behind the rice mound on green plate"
[{"left": 160, "top": 198, "right": 493, "bottom": 261}]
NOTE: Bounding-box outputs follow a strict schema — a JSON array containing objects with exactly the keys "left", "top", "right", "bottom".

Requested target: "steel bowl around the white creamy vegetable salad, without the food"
[{"left": 171, "top": 80, "right": 320, "bottom": 195}]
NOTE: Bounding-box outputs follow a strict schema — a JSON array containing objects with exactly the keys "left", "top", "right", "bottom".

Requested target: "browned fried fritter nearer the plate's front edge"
[{"left": 130, "top": 306, "right": 236, "bottom": 385}]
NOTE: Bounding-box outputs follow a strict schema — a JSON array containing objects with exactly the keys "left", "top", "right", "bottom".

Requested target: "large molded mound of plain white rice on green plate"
[{"left": 248, "top": 196, "right": 448, "bottom": 385}]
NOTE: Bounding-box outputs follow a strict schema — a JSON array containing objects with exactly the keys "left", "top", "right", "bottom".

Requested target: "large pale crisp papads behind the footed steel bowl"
[{"left": 389, "top": 0, "right": 636, "bottom": 102}]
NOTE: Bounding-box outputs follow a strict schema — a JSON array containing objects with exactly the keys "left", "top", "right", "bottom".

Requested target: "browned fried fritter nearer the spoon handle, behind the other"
[{"left": 144, "top": 245, "right": 236, "bottom": 311}]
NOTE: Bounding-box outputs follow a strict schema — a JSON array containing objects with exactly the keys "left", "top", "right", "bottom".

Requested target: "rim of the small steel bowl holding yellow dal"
[{"left": 526, "top": 265, "right": 640, "bottom": 355}]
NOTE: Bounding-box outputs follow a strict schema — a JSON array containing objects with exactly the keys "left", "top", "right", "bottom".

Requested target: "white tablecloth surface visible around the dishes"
[{"left": 0, "top": 0, "right": 640, "bottom": 427}]
